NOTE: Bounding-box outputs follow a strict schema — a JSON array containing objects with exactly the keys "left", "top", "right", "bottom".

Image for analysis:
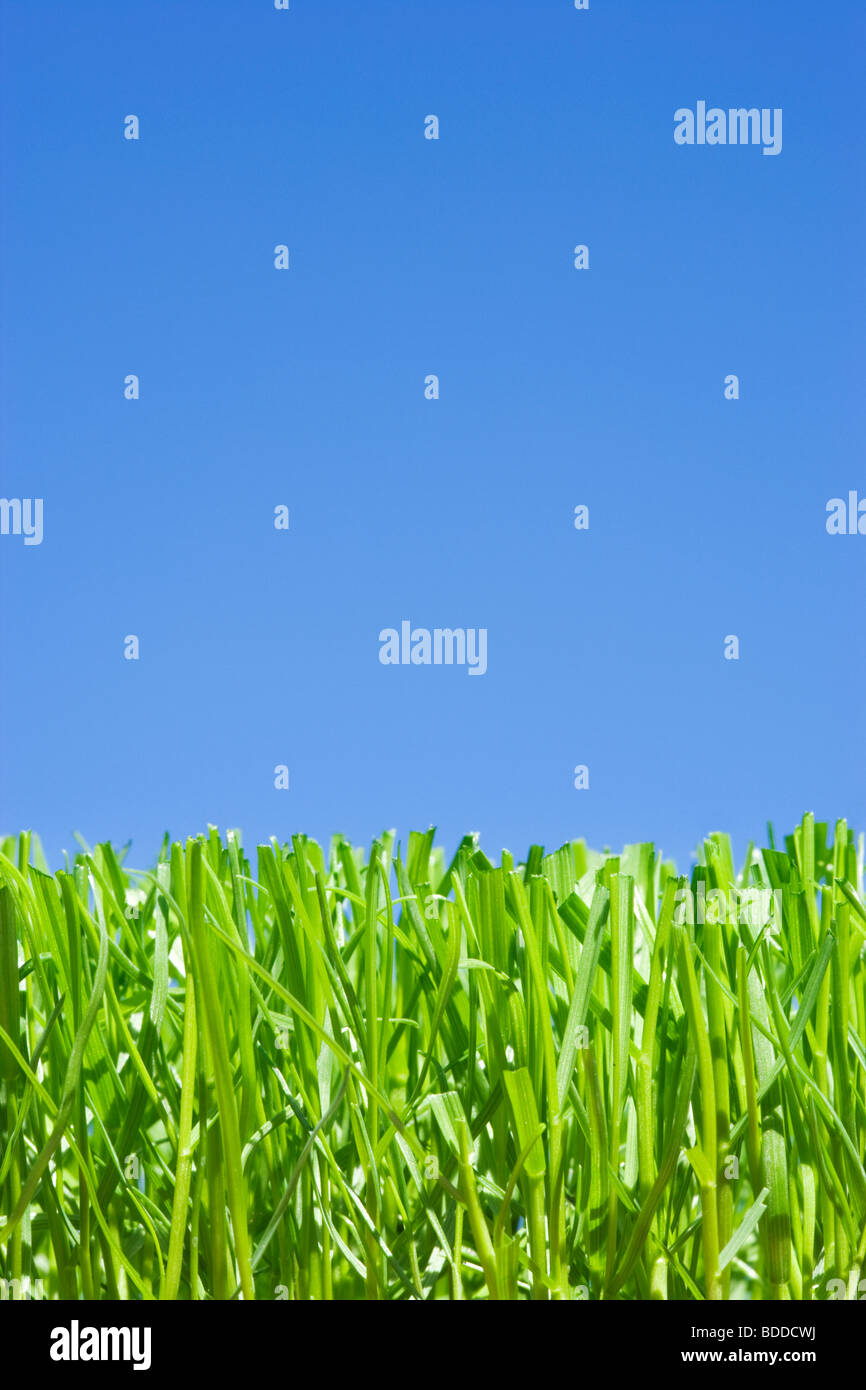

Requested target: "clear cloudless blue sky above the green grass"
[{"left": 0, "top": 0, "right": 866, "bottom": 863}]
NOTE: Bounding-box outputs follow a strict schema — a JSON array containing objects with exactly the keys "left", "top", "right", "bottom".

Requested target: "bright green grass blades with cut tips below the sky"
[{"left": 0, "top": 816, "right": 866, "bottom": 1300}]
